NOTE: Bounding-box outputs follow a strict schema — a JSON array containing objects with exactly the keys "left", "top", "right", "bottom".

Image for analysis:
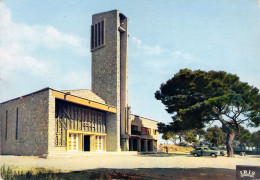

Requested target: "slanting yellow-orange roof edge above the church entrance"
[{"left": 51, "top": 89, "right": 117, "bottom": 113}]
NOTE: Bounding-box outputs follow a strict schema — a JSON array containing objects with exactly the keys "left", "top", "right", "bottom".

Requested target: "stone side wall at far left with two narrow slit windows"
[{"left": 0, "top": 89, "right": 50, "bottom": 155}]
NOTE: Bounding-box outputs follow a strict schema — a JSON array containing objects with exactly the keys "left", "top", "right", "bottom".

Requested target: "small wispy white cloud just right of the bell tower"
[{"left": 132, "top": 37, "right": 165, "bottom": 55}]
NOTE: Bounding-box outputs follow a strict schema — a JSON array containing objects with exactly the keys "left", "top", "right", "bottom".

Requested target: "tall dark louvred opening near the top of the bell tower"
[{"left": 91, "top": 20, "right": 105, "bottom": 51}]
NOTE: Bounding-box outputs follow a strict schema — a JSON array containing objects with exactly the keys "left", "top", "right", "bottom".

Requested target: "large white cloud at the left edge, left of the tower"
[{"left": 0, "top": 3, "right": 88, "bottom": 81}]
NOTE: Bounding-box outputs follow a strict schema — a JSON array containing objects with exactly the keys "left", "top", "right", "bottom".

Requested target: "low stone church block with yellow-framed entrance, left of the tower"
[{"left": 0, "top": 88, "right": 120, "bottom": 157}]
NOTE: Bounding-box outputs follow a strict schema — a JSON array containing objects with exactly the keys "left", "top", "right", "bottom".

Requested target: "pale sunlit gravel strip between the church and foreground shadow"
[{"left": 0, "top": 154, "right": 260, "bottom": 172}]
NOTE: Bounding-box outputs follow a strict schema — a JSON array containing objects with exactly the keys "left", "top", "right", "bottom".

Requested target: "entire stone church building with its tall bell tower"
[{"left": 0, "top": 10, "right": 158, "bottom": 157}]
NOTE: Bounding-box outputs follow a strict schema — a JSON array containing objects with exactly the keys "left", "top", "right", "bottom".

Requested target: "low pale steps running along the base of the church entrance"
[{"left": 42, "top": 151, "right": 139, "bottom": 159}]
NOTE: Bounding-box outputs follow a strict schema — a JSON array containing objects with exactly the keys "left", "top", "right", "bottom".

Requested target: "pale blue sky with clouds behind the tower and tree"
[{"left": 0, "top": 0, "right": 260, "bottom": 138}]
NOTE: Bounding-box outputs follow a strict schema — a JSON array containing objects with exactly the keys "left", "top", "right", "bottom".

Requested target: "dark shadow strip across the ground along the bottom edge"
[{"left": 7, "top": 168, "right": 236, "bottom": 180}]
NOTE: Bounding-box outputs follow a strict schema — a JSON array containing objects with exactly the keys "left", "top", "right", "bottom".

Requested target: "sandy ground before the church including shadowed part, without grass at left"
[{"left": 0, "top": 154, "right": 260, "bottom": 180}]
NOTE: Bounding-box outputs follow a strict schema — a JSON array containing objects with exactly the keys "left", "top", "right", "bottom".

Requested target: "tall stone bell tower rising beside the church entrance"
[{"left": 91, "top": 10, "right": 131, "bottom": 151}]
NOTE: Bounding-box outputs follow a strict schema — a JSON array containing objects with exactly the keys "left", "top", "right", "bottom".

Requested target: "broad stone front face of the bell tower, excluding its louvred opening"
[{"left": 92, "top": 10, "right": 121, "bottom": 151}]
